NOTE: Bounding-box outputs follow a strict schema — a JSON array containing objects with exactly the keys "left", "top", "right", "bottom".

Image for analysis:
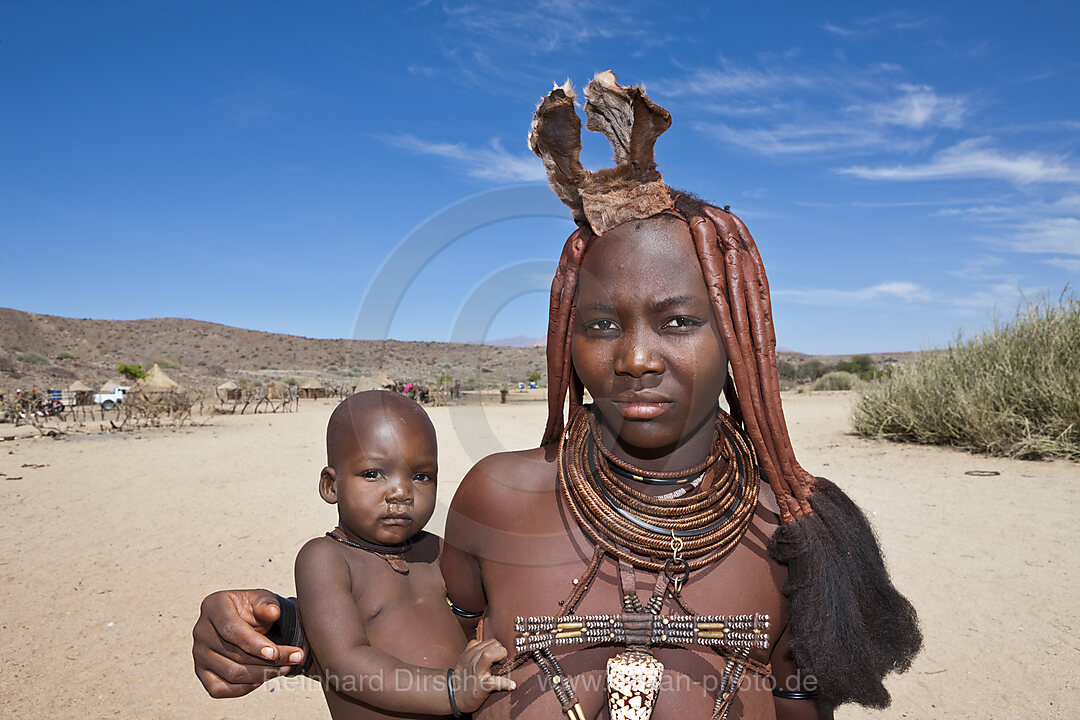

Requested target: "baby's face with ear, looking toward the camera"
[{"left": 320, "top": 413, "right": 438, "bottom": 545}]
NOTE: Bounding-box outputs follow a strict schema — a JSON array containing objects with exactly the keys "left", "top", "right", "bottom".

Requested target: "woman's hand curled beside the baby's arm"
[{"left": 191, "top": 589, "right": 303, "bottom": 697}]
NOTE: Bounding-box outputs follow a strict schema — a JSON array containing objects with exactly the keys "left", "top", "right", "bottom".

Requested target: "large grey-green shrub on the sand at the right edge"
[{"left": 852, "top": 296, "right": 1080, "bottom": 460}]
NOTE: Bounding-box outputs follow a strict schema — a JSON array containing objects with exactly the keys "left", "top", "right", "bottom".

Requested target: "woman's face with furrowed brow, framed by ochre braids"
[{"left": 572, "top": 216, "right": 728, "bottom": 458}]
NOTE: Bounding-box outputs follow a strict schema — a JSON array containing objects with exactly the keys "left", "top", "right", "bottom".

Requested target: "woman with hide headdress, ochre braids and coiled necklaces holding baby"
[{"left": 194, "top": 72, "right": 921, "bottom": 720}]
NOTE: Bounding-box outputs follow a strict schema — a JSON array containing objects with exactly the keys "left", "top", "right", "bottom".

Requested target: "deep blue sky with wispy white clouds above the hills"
[{"left": 0, "top": 1, "right": 1080, "bottom": 353}]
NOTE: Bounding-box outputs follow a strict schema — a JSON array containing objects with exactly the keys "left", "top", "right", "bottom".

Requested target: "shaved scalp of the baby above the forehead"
[{"left": 326, "top": 390, "right": 435, "bottom": 467}]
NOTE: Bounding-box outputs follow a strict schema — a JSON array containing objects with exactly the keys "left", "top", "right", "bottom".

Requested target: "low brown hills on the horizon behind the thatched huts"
[{"left": 0, "top": 308, "right": 919, "bottom": 392}]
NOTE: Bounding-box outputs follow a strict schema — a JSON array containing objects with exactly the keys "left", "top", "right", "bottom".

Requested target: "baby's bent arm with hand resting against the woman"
[{"left": 296, "top": 538, "right": 514, "bottom": 715}]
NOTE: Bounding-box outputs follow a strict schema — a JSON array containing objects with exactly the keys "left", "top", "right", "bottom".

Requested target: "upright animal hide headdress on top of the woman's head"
[{"left": 529, "top": 70, "right": 675, "bottom": 235}]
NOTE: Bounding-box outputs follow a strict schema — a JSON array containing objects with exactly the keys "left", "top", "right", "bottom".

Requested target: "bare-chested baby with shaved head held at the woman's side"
[{"left": 296, "top": 391, "right": 514, "bottom": 720}]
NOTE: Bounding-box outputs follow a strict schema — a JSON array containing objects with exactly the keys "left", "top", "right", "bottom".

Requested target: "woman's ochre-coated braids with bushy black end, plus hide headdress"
[{"left": 529, "top": 72, "right": 921, "bottom": 707}]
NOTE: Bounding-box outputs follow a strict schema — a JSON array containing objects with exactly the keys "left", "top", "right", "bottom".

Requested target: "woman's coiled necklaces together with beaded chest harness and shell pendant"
[{"left": 502, "top": 407, "right": 771, "bottom": 720}]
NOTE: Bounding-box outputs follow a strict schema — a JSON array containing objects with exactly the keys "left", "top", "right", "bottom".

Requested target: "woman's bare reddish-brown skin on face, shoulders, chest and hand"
[{"left": 195, "top": 218, "right": 832, "bottom": 720}]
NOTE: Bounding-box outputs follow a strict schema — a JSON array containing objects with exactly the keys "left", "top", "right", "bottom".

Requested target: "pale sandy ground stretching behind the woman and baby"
[{"left": 0, "top": 393, "right": 1080, "bottom": 720}]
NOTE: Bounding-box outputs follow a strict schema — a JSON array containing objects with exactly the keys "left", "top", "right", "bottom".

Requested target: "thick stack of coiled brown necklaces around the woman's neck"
[{"left": 557, "top": 407, "right": 759, "bottom": 584}]
